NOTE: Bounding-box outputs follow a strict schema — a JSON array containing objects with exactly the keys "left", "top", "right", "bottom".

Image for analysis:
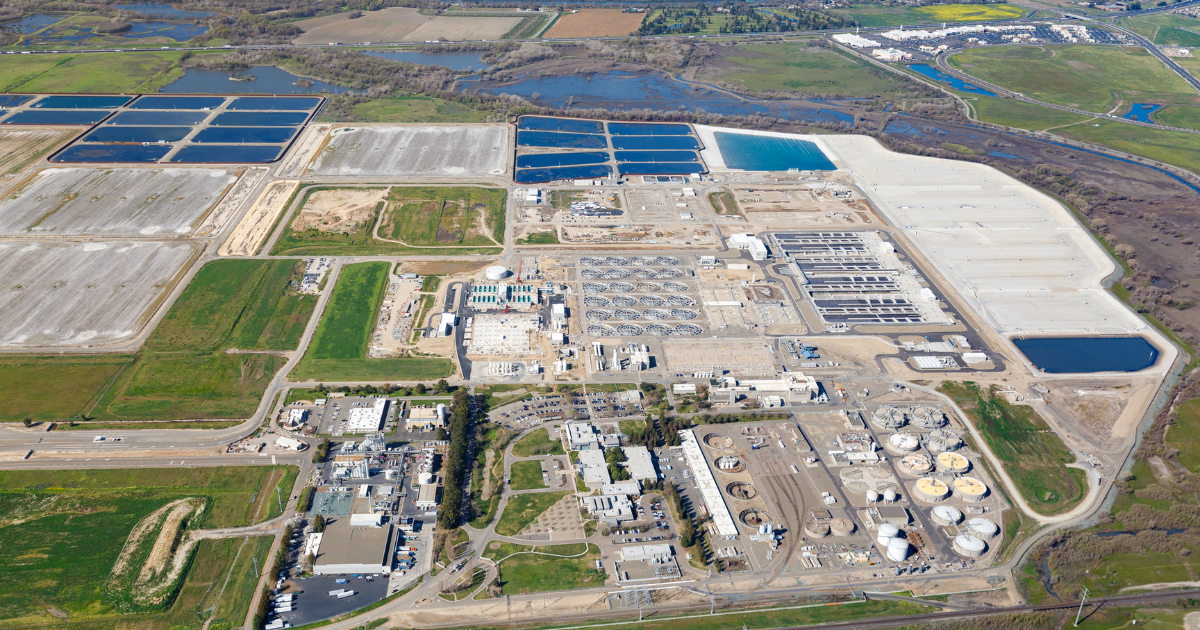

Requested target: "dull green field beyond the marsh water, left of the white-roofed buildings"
[{"left": 697, "top": 43, "right": 913, "bottom": 97}]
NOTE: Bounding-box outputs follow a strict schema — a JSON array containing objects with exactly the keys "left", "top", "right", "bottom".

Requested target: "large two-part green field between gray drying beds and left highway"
[{"left": 0, "top": 260, "right": 316, "bottom": 426}]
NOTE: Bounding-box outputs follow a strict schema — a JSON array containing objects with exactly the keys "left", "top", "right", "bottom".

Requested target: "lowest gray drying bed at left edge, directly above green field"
[{"left": 0, "top": 240, "right": 198, "bottom": 348}]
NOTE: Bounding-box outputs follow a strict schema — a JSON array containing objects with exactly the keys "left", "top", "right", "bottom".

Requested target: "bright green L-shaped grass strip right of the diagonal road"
[{"left": 288, "top": 262, "right": 454, "bottom": 382}]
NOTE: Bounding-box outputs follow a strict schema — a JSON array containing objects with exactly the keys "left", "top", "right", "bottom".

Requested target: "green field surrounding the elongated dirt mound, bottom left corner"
[{"left": 0, "top": 466, "right": 295, "bottom": 630}]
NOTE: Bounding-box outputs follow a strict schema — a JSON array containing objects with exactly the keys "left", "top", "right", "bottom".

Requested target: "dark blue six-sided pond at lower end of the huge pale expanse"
[{"left": 1013, "top": 337, "right": 1158, "bottom": 374}]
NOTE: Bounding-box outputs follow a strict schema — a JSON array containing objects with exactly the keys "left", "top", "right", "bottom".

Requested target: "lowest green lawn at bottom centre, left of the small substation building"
[{"left": 485, "top": 542, "right": 606, "bottom": 595}]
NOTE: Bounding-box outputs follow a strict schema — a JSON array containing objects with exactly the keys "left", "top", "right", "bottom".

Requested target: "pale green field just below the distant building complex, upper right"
[{"left": 950, "top": 46, "right": 1200, "bottom": 112}]
